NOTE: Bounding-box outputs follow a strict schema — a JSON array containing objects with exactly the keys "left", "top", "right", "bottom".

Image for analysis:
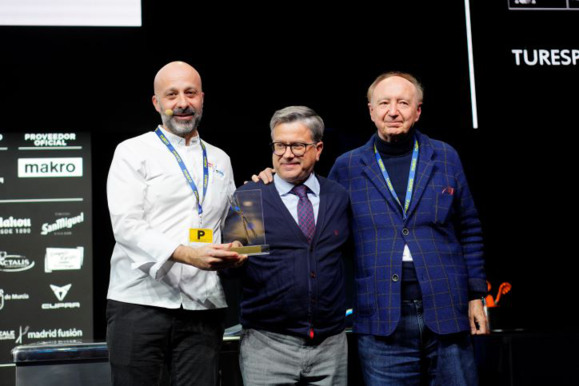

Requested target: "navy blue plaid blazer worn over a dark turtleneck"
[{"left": 329, "top": 131, "right": 487, "bottom": 336}]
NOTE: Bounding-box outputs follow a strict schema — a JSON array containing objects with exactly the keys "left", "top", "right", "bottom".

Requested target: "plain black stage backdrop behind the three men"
[{"left": 0, "top": 1, "right": 579, "bottom": 339}]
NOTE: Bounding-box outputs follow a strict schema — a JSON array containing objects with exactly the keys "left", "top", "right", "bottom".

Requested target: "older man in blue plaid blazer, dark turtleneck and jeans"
[{"left": 329, "top": 72, "right": 487, "bottom": 385}]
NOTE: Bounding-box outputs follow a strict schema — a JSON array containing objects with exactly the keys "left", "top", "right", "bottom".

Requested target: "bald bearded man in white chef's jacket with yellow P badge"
[{"left": 106, "top": 62, "right": 247, "bottom": 386}]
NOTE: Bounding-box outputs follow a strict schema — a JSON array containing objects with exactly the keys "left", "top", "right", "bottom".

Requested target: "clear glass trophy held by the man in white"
[{"left": 223, "top": 190, "right": 269, "bottom": 256}]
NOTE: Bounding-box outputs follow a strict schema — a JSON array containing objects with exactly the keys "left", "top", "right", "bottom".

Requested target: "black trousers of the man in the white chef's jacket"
[{"left": 106, "top": 300, "right": 225, "bottom": 386}]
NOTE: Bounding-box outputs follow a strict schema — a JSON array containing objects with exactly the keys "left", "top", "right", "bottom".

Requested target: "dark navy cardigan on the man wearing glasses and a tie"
[{"left": 233, "top": 176, "right": 350, "bottom": 338}]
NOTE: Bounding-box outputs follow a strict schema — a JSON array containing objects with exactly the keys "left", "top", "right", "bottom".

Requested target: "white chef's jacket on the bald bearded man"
[{"left": 107, "top": 126, "right": 235, "bottom": 310}]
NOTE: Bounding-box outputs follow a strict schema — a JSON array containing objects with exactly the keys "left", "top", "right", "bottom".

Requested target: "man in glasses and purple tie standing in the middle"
[{"left": 233, "top": 106, "right": 349, "bottom": 386}]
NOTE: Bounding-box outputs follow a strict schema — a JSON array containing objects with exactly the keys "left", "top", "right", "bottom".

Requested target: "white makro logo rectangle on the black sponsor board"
[{"left": 18, "top": 158, "right": 82, "bottom": 178}]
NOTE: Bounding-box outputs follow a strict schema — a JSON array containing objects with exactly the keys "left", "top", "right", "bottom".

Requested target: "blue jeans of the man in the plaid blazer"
[{"left": 358, "top": 300, "right": 478, "bottom": 386}]
